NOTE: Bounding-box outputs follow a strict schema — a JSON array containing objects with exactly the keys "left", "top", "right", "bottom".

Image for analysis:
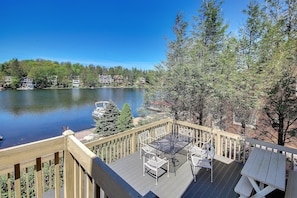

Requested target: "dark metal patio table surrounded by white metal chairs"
[{"left": 149, "top": 133, "right": 193, "bottom": 174}]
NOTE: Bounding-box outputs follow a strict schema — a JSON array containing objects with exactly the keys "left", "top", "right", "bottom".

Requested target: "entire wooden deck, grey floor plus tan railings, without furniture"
[{"left": 0, "top": 119, "right": 297, "bottom": 198}]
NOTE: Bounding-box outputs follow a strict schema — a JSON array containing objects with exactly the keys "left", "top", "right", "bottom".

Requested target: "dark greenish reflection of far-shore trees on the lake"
[{"left": 0, "top": 88, "right": 143, "bottom": 115}]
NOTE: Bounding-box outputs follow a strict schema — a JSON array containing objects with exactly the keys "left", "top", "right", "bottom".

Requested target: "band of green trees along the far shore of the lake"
[{"left": 0, "top": 59, "right": 154, "bottom": 88}]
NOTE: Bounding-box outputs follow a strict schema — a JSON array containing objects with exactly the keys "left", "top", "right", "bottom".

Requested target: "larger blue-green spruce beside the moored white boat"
[{"left": 95, "top": 100, "right": 120, "bottom": 136}]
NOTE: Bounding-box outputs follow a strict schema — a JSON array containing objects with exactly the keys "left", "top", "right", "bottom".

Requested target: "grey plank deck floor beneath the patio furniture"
[{"left": 109, "top": 152, "right": 284, "bottom": 198}]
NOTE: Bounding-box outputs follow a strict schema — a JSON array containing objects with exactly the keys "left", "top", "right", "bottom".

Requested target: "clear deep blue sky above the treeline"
[{"left": 0, "top": 0, "right": 249, "bottom": 69}]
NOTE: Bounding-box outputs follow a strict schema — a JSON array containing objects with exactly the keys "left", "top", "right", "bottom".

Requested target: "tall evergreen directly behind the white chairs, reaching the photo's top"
[{"left": 188, "top": 0, "right": 228, "bottom": 125}]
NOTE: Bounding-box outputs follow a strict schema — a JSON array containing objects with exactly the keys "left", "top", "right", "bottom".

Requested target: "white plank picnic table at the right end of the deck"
[{"left": 241, "top": 148, "right": 286, "bottom": 197}]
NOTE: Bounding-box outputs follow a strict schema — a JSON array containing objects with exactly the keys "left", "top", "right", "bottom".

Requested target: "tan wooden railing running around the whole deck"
[{"left": 0, "top": 119, "right": 297, "bottom": 198}]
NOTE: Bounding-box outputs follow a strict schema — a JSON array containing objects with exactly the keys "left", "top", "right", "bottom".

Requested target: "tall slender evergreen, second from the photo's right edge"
[{"left": 229, "top": 1, "right": 264, "bottom": 135}]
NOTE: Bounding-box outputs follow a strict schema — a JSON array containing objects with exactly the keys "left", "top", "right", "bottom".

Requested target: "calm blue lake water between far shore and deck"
[{"left": 0, "top": 88, "right": 144, "bottom": 149}]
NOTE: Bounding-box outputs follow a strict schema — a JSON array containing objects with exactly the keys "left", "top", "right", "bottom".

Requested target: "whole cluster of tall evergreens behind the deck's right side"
[{"left": 145, "top": 0, "right": 297, "bottom": 144}]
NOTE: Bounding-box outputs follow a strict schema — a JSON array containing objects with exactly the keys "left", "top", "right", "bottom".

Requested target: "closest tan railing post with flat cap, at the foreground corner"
[{"left": 63, "top": 130, "right": 77, "bottom": 197}]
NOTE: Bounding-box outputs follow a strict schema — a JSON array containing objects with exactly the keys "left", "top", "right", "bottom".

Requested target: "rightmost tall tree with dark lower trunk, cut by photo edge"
[{"left": 260, "top": 0, "right": 297, "bottom": 145}]
